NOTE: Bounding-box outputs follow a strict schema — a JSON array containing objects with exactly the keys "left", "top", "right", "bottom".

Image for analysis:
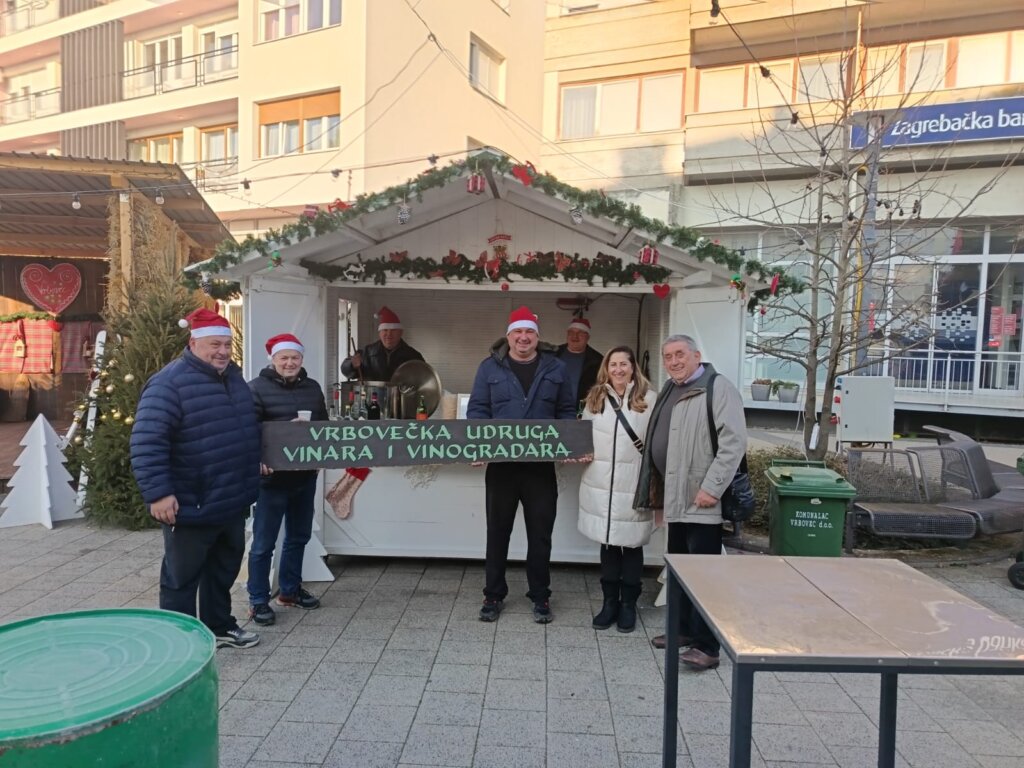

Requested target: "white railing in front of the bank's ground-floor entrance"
[{"left": 862, "top": 349, "right": 1021, "bottom": 395}]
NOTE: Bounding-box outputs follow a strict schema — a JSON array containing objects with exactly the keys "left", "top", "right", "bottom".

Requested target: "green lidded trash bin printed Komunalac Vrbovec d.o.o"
[{"left": 765, "top": 462, "right": 857, "bottom": 557}]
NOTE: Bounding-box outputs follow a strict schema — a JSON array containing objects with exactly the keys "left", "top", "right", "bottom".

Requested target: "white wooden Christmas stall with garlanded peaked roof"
[{"left": 189, "top": 154, "right": 793, "bottom": 563}]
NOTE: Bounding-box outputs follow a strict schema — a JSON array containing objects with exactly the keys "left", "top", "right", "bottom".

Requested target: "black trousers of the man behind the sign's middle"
[{"left": 483, "top": 462, "right": 558, "bottom": 603}]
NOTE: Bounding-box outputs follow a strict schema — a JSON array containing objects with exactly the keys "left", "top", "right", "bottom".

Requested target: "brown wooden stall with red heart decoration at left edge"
[{"left": 0, "top": 153, "right": 228, "bottom": 422}]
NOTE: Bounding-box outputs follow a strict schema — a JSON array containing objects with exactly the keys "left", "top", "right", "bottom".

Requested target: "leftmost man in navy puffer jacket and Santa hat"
[{"left": 131, "top": 309, "right": 260, "bottom": 648}]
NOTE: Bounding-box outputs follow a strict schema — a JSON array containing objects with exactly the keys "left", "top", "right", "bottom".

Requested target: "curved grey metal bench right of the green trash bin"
[{"left": 848, "top": 442, "right": 1024, "bottom": 543}]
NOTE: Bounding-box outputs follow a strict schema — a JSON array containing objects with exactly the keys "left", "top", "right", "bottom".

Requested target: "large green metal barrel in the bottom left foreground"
[{"left": 0, "top": 608, "right": 217, "bottom": 768}]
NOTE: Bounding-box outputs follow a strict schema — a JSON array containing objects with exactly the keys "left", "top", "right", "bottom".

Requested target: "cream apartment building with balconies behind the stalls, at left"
[{"left": 0, "top": 0, "right": 544, "bottom": 237}]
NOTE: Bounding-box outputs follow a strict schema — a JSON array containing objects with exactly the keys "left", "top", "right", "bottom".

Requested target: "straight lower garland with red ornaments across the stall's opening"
[{"left": 300, "top": 251, "right": 671, "bottom": 287}]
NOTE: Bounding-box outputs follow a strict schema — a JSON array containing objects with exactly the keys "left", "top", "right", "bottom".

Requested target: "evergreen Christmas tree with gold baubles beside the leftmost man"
[{"left": 73, "top": 276, "right": 198, "bottom": 530}]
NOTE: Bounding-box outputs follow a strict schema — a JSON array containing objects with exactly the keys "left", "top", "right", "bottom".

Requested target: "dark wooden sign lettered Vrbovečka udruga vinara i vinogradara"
[{"left": 262, "top": 420, "right": 594, "bottom": 470}]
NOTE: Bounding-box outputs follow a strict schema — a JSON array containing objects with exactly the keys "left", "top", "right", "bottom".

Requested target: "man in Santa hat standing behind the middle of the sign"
[{"left": 466, "top": 306, "right": 577, "bottom": 624}]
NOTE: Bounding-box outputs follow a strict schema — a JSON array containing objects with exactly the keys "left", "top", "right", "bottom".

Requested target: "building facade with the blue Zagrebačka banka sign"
[{"left": 545, "top": 0, "right": 1024, "bottom": 415}]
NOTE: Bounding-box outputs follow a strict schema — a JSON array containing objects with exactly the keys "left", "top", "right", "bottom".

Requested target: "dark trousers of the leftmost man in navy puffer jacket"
[{"left": 160, "top": 512, "right": 246, "bottom": 635}]
